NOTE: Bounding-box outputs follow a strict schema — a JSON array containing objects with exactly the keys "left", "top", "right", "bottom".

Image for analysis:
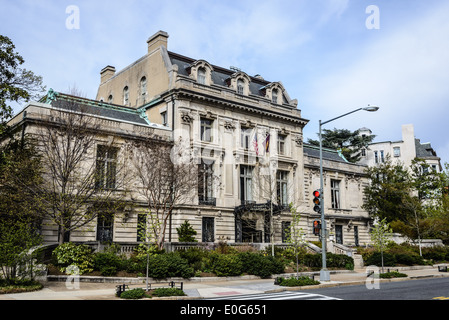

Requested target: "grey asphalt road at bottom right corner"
[{"left": 307, "top": 278, "right": 449, "bottom": 300}]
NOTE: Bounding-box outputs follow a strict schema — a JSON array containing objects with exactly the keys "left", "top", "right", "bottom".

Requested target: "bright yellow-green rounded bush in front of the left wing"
[{"left": 53, "top": 242, "right": 93, "bottom": 274}]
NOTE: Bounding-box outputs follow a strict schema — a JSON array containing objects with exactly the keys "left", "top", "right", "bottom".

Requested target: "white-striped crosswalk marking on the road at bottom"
[{"left": 207, "top": 291, "right": 340, "bottom": 300}]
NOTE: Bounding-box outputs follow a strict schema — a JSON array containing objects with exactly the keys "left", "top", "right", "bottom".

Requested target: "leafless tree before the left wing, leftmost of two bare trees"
[{"left": 36, "top": 91, "right": 124, "bottom": 243}]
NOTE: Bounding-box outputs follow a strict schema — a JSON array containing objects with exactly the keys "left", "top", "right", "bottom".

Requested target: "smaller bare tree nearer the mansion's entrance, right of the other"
[{"left": 131, "top": 135, "right": 198, "bottom": 249}]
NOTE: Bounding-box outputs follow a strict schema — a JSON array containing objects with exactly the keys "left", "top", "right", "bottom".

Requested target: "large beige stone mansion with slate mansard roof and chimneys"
[{"left": 10, "top": 31, "right": 371, "bottom": 250}]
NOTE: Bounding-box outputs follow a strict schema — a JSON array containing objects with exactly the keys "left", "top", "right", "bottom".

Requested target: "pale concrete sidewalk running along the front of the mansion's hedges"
[{"left": 0, "top": 266, "right": 449, "bottom": 300}]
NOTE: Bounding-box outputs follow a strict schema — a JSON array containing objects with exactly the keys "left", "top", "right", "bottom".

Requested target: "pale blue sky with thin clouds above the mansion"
[{"left": 0, "top": 0, "right": 449, "bottom": 163}]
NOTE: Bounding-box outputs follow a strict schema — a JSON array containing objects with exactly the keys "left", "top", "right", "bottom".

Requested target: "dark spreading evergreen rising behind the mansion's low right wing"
[{"left": 308, "top": 128, "right": 376, "bottom": 163}]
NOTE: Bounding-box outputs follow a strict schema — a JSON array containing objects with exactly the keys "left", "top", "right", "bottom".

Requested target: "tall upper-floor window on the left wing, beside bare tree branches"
[{"left": 95, "top": 145, "right": 118, "bottom": 189}]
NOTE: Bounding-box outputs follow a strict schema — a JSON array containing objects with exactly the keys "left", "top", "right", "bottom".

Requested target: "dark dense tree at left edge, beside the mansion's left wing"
[{"left": 0, "top": 140, "right": 42, "bottom": 283}]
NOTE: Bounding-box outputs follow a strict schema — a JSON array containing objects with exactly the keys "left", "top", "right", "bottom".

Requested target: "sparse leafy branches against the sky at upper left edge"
[{"left": 0, "top": 35, "right": 45, "bottom": 134}]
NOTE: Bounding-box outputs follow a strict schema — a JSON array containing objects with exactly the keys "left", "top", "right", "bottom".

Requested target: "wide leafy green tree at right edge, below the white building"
[{"left": 363, "top": 158, "right": 449, "bottom": 249}]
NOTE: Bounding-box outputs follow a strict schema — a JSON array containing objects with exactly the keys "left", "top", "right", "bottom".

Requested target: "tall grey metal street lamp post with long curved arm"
[{"left": 319, "top": 105, "right": 379, "bottom": 281}]
